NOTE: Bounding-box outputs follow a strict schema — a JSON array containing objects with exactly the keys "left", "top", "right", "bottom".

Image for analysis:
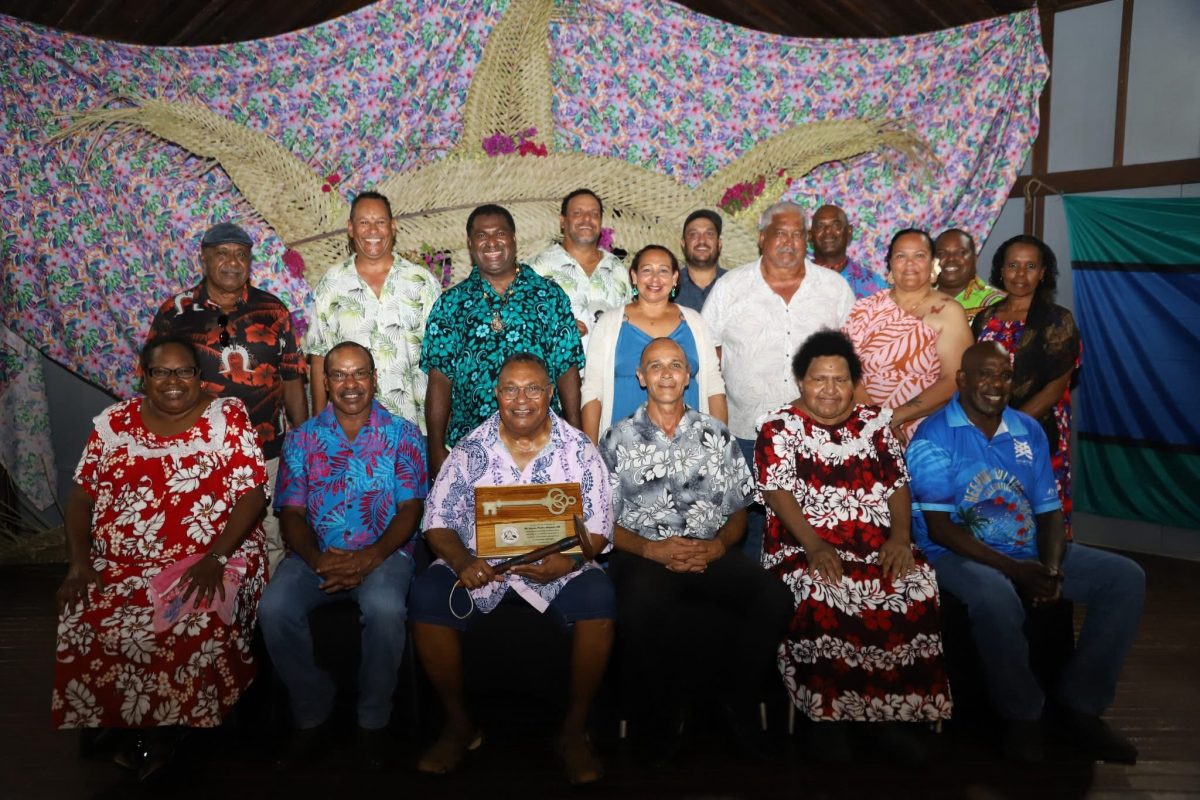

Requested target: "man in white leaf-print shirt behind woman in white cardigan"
[{"left": 528, "top": 188, "right": 632, "bottom": 353}]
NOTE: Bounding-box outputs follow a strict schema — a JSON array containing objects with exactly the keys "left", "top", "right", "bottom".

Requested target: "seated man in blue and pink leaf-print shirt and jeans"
[{"left": 258, "top": 342, "right": 428, "bottom": 769}]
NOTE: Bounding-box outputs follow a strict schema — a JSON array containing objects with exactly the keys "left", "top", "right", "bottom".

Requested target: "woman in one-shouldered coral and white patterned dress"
[{"left": 842, "top": 228, "right": 973, "bottom": 443}]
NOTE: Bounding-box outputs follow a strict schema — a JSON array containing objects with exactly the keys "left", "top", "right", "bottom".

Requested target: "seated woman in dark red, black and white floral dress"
[{"left": 755, "top": 330, "right": 950, "bottom": 760}]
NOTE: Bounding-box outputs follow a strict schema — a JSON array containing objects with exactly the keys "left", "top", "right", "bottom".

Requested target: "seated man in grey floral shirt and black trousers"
[{"left": 600, "top": 338, "right": 792, "bottom": 763}]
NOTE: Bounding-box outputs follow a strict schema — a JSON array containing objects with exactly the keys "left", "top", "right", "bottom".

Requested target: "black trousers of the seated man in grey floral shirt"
[{"left": 608, "top": 549, "right": 794, "bottom": 724}]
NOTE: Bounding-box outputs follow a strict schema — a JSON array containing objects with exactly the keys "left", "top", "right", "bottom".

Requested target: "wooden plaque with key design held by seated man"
[{"left": 475, "top": 483, "right": 583, "bottom": 558}]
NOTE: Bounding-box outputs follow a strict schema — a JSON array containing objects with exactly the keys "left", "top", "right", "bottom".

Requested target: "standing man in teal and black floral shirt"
[{"left": 421, "top": 204, "right": 583, "bottom": 475}]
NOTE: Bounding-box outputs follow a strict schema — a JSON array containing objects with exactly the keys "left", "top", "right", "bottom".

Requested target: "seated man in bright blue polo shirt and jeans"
[{"left": 906, "top": 342, "right": 1146, "bottom": 763}]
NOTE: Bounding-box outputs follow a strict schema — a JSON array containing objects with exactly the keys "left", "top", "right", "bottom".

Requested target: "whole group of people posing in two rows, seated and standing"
[{"left": 52, "top": 190, "right": 1144, "bottom": 783}]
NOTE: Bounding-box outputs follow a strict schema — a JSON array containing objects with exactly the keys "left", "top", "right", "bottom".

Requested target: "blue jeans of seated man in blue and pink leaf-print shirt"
[{"left": 258, "top": 551, "right": 413, "bottom": 730}]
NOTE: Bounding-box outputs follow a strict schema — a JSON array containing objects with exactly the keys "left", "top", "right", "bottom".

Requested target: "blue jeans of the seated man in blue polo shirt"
[{"left": 934, "top": 545, "right": 1146, "bottom": 720}]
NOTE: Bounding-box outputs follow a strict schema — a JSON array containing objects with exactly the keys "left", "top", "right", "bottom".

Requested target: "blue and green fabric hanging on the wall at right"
[{"left": 1064, "top": 197, "right": 1200, "bottom": 528}]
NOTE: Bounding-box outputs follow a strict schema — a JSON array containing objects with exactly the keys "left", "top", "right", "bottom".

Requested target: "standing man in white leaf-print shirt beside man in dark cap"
[{"left": 305, "top": 192, "right": 442, "bottom": 433}]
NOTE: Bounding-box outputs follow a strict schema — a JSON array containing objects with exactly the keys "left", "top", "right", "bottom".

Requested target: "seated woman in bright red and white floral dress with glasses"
[{"left": 52, "top": 338, "right": 266, "bottom": 777}]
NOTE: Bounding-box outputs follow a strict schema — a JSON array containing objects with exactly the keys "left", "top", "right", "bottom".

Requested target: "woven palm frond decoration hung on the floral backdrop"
[{"left": 55, "top": 0, "right": 934, "bottom": 284}]
